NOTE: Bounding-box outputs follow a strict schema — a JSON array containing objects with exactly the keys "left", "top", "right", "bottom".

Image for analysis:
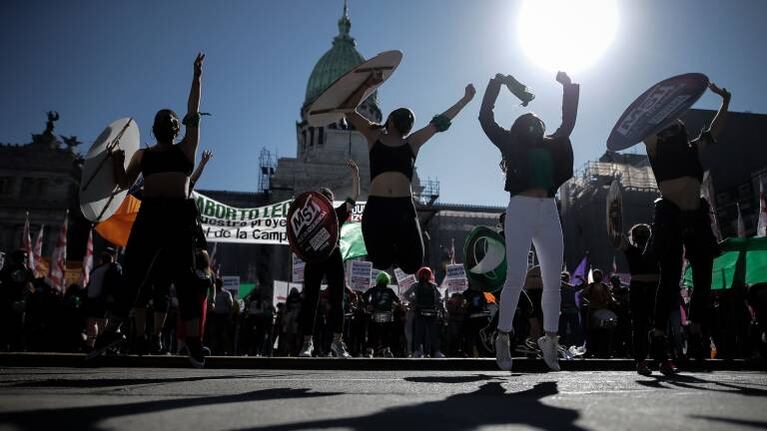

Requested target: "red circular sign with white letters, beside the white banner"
[{"left": 287, "top": 192, "right": 339, "bottom": 263}]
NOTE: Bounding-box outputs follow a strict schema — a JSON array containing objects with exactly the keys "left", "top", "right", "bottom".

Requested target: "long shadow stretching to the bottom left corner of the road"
[{"left": 0, "top": 389, "right": 338, "bottom": 430}]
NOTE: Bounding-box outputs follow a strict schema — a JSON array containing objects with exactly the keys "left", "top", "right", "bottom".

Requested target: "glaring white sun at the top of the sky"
[{"left": 517, "top": 0, "right": 618, "bottom": 73}]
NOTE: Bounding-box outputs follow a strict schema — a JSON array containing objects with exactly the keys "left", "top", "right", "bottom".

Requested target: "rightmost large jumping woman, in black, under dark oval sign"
[{"left": 644, "top": 83, "right": 731, "bottom": 372}]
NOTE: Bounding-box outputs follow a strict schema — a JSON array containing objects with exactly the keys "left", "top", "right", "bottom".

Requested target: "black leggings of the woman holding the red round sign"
[{"left": 298, "top": 247, "right": 344, "bottom": 336}]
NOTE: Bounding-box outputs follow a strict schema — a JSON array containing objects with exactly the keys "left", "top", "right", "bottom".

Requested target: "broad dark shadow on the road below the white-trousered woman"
[{"left": 237, "top": 382, "right": 583, "bottom": 431}]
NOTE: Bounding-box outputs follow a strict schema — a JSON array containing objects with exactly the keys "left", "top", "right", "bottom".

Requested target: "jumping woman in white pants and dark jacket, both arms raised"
[{"left": 479, "top": 72, "right": 579, "bottom": 371}]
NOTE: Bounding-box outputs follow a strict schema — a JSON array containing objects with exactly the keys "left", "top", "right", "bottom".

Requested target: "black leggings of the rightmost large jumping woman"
[{"left": 651, "top": 199, "right": 719, "bottom": 332}]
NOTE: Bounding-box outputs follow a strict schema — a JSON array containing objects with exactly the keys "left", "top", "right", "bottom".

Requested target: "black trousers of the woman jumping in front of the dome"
[{"left": 362, "top": 196, "right": 424, "bottom": 274}]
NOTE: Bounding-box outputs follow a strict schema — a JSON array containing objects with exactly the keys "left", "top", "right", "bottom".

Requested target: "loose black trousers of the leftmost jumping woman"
[{"left": 115, "top": 198, "right": 204, "bottom": 320}]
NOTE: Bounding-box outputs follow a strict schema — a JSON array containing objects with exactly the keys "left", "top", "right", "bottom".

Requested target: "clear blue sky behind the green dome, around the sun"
[{"left": 0, "top": 0, "right": 767, "bottom": 205}]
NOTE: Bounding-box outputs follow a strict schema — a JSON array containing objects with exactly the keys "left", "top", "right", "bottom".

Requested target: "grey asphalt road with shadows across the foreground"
[{"left": 0, "top": 368, "right": 767, "bottom": 431}]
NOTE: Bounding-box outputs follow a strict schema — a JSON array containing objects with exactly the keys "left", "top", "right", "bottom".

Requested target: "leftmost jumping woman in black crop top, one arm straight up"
[{"left": 95, "top": 54, "right": 213, "bottom": 367}]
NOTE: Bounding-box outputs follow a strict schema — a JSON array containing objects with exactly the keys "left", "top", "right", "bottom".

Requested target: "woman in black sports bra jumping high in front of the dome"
[{"left": 346, "top": 74, "right": 475, "bottom": 274}]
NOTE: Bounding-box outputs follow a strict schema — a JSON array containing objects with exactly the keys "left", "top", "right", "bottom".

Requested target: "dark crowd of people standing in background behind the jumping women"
[{"left": 0, "top": 245, "right": 767, "bottom": 370}]
